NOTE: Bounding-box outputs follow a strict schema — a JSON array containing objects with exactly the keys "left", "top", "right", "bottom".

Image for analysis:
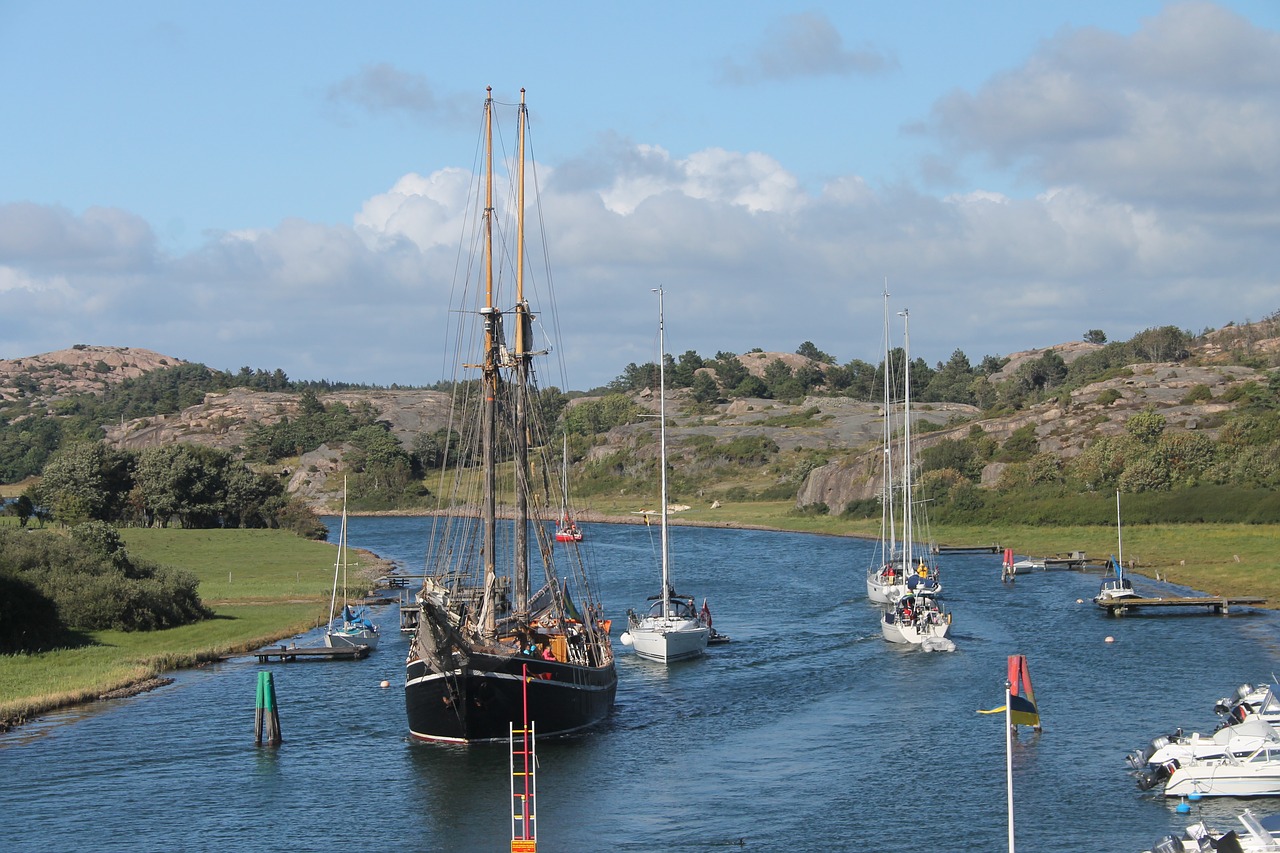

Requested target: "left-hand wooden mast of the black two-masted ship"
[{"left": 480, "top": 86, "right": 500, "bottom": 639}]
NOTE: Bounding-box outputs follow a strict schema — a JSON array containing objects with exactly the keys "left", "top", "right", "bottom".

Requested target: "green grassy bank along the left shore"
[{"left": 0, "top": 529, "right": 381, "bottom": 720}]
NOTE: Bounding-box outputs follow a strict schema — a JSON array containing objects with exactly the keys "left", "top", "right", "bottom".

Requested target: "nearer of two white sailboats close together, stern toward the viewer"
[{"left": 868, "top": 310, "right": 955, "bottom": 651}]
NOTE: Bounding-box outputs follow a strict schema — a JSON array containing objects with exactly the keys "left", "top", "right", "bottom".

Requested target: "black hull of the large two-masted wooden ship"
[{"left": 404, "top": 653, "right": 618, "bottom": 743}]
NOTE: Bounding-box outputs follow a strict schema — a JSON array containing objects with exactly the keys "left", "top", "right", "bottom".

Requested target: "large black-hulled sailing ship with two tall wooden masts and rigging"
[{"left": 404, "top": 90, "right": 617, "bottom": 743}]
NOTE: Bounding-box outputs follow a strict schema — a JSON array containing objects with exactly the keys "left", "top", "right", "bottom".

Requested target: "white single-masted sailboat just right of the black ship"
[{"left": 621, "top": 288, "right": 710, "bottom": 663}]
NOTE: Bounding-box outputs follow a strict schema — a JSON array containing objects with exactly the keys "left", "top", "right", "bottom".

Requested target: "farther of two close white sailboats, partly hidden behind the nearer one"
[{"left": 867, "top": 291, "right": 942, "bottom": 605}]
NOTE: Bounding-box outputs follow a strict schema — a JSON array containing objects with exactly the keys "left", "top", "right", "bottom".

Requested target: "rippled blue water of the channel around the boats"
[{"left": 0, "top": 517, "right": 1280, "bottom": 853}]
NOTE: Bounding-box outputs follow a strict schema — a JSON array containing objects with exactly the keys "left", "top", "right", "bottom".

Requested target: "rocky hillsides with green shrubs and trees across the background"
[{"left": 0, "top": 315, "right": 1280, "bottom": 526}]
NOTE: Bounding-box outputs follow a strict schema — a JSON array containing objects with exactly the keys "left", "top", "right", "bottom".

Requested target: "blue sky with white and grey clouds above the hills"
[{"left": 0, "top": 0, "right": 1280, "bottom": 389}]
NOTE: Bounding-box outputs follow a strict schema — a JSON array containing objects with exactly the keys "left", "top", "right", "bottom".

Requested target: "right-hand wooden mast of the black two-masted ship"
[{"left": 512, "top": 88, "right": 530, "bottom": 619}]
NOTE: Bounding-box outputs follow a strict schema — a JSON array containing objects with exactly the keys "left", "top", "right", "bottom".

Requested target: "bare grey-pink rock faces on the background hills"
[{"left": 0, "top": 318, "right": 1280, "bottom": 514}]
